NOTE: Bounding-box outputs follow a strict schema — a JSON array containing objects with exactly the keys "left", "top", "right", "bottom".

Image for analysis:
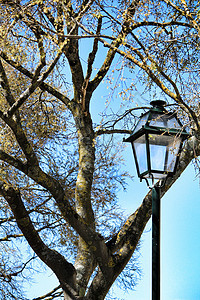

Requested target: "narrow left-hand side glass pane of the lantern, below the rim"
[{"left": 133, "top": 136, "right": 148, "bottom": 174}]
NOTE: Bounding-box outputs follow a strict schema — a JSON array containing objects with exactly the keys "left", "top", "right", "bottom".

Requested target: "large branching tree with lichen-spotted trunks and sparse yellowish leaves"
[{"left": 0, "top": 0, "right": 200, "bottom": 300}]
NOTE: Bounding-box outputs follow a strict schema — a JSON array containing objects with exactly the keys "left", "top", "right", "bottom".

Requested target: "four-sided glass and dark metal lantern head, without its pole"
[{"left": 124, "top": 100, "right": 189, "bottom": 186}]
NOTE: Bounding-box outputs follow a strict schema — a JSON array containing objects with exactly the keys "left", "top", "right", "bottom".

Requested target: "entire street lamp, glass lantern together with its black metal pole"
[{"left": 124, "top": 100, "right": 189, "bottom": 300}]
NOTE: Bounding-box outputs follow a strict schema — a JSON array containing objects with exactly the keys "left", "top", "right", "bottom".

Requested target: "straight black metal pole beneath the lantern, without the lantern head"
[{"left": 152, "top": 186, "right": 160, "bottom": 300}]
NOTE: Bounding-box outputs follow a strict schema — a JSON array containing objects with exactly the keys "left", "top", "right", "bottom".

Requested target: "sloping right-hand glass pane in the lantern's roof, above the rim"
[{"left": 149, "top": 113, "right": 181, "bottom": 129}]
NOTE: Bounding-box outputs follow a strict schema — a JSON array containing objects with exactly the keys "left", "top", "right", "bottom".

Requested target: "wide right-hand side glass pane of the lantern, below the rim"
[{"left": 149, "top": 134, "right": 181, "bottom": 173}]
